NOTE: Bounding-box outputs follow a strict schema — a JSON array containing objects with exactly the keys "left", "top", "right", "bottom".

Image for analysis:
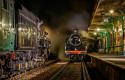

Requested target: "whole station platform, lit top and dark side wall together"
[{"left": 87, "top": 53, "right": 125, "bottom": 80}]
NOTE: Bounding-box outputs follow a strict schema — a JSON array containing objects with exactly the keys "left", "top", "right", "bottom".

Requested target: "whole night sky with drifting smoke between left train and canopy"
[{"left": 20, "top": 0, "right": 96, "bottom": 58}]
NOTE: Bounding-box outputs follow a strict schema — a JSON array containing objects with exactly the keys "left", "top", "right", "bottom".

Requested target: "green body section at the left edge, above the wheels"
[{"left": 0, "top": 0, "right": 15, "bottom": 51}]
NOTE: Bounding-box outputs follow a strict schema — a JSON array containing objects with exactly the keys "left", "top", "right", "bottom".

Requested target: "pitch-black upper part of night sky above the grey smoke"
[{"left": 20, "top": 0, "right": 95, "bottom": 27}]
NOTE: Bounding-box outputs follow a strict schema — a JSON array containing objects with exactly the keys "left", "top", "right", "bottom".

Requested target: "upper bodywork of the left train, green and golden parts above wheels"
[{"left": 0, "top": 0, "right": 38, "bottom": 52}]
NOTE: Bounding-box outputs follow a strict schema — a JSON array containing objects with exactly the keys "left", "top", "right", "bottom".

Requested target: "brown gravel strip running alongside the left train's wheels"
[{"left": 6, "top": 60, "right": 57, "bottom": 80}]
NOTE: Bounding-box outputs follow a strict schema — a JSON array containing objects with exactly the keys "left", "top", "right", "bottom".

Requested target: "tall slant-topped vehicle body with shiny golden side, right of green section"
[{"left": 15, "top": 5, "right": 39, "bottom": 49}]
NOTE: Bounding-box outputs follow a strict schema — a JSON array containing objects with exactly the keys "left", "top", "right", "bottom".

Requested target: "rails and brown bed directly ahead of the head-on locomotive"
[{"left": 49, "top": 62, "right": 91, "bottom": 80}]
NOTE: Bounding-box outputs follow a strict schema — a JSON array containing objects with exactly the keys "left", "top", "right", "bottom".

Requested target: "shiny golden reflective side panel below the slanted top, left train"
[{"left": 18, "top": 16, "right": 36, "bottom": 48}]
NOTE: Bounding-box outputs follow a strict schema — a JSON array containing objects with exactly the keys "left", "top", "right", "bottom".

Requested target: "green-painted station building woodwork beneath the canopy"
[{"left": 98, "top": 16, "right": 125, "bottom": 55}]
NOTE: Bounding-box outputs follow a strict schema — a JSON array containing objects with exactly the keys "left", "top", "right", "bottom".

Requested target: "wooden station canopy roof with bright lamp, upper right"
[{"left": 89, "top": 0, "right": 125, "bottom": 28}]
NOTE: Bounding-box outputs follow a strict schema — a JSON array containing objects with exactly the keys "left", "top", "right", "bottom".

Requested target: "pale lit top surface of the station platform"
[{"left": 88, "top": 53, "right": 125, "bottom": 69}]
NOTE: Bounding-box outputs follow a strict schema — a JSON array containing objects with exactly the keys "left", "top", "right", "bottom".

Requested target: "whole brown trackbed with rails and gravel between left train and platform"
[{"left": 9, "top": 62, "right": 102, "bottom": 80}]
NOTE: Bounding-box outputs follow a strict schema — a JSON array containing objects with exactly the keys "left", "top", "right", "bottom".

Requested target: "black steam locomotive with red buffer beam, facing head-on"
[{"left": 65, "top": 29, "right": 87, "bottom": 61}]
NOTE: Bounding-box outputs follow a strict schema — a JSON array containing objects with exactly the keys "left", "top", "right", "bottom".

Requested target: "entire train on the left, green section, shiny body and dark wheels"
[{"left": 0, "top": 0, "right": 51, "bottom": 79}]
